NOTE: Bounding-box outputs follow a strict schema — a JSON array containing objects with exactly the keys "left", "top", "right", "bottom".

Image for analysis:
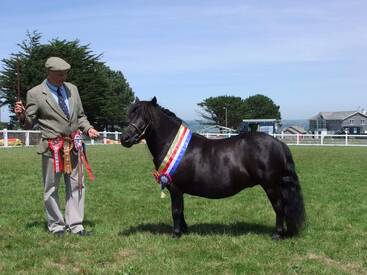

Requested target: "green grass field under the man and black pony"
[{"left": 0, "top": 145, "right": 367, "bottom": 274}]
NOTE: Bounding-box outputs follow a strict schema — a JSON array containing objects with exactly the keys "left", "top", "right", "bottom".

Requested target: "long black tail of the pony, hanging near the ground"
[{"left": 281, "top": 145, "right": 306, "bottom": 236}]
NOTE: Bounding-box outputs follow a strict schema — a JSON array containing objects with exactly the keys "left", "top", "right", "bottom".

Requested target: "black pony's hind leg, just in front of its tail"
[{"left": 263, "top": 186, "right": 286, "bottom": 240}]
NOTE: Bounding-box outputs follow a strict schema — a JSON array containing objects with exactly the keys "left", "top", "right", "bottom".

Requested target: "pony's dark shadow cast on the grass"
[{"left": 118, "top": 222, "right": 274, "bottom": 236}]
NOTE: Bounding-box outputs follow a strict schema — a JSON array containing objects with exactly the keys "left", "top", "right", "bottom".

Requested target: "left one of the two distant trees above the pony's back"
[{"left": 198, "top": 95, "right": 243, "bottom": 129}]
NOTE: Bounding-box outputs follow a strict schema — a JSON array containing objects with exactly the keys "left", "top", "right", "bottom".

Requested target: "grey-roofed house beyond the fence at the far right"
[{"left": 309, "top": 111, "right": 367, "bottom": 135}]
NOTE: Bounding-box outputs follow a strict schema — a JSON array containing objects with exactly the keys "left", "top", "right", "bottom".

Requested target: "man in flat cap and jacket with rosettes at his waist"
[{"left": 14, "top": 57, "right": 99, "bottom": 236}]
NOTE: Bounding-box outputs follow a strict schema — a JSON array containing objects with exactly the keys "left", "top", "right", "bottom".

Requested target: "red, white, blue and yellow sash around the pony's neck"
[{"left": 153, "top": 124, "right": 192, "bottom": 196}]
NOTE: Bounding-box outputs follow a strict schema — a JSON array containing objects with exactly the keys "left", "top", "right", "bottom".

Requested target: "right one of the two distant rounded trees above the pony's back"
[{"left": 243, "top": 94, "right": 281, "bottom": 120}]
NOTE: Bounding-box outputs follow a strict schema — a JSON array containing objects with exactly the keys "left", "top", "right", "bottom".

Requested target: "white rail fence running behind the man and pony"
[{"left": 0, "top": 129, "right": 367, "bottom": 148}]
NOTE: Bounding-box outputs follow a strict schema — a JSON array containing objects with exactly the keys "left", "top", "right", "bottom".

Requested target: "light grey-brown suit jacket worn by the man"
[{"left": 23, "top": 80, "right": 92, "bottom": 154}]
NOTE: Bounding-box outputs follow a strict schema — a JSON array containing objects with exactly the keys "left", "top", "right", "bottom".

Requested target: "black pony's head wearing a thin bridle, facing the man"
[{"left": 121, "top": 97, "right": 157, "bottom": 147}]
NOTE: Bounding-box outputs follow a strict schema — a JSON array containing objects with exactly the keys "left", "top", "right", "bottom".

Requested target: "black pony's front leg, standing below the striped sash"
[{"left": 169, "top": 186, "right": 187, "bottom": 238}]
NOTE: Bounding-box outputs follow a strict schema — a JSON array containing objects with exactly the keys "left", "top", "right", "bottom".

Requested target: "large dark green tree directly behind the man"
[{"left": 0, "top": 31, "right": 134, "bottom": 130}]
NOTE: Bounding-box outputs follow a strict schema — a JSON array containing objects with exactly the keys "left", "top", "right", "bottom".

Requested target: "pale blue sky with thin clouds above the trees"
[{"left": 0, "top": 0, "right": 367, "bottom": 120}]
